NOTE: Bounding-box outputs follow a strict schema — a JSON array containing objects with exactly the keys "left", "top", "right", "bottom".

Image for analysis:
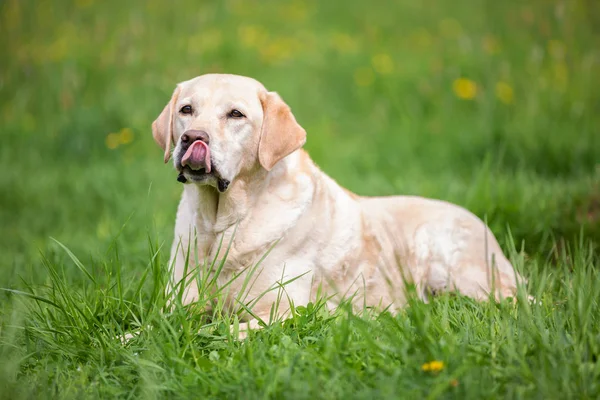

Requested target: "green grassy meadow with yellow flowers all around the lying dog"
[{"left": 0, "top": 0, "right": 600, "bottom": 399}]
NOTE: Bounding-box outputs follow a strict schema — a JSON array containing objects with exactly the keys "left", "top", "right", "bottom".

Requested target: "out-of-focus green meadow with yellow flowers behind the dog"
[{"left": 0, "top": 0, "right": 600, "bottom": 287}]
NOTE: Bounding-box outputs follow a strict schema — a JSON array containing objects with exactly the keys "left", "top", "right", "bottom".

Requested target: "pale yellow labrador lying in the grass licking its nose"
[{"left": 152, "top": 74, "right": 521, "bottom": 334}]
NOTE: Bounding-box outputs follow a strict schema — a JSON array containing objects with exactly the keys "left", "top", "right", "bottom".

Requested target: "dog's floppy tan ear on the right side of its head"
[{"left": 258, "top": 92, "right": 306, "bottom": 171}]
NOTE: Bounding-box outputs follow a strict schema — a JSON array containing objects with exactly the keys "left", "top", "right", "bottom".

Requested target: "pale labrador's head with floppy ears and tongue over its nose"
[{"left": 152, "top": 74, "right": 306, "bottom": 192}]
